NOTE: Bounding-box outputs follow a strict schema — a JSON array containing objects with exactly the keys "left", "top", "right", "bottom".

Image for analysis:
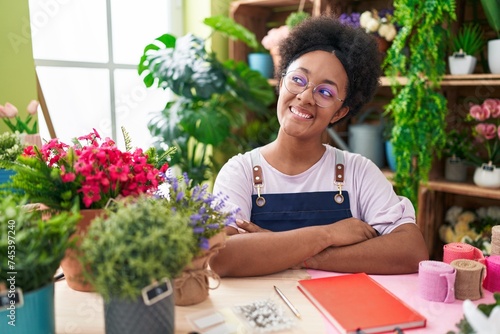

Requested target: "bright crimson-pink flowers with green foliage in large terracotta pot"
[{"left": 4, "top": 130, "right": 168, "bottom": 210}]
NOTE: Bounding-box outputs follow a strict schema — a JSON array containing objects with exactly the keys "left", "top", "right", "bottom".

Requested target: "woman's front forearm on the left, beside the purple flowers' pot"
[{"left": 210, "top": 226, "right": 332, "bottom": 277}]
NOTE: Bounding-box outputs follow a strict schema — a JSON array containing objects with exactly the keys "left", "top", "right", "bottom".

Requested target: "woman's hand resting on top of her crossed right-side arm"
[{"left": 328, "top": 218, "right": 377, "bottom": 246}]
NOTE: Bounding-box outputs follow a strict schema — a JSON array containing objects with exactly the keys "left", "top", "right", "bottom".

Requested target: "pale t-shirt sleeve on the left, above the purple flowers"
[{"left": 213, "top": 154, "right": 253, "bottom": 227}]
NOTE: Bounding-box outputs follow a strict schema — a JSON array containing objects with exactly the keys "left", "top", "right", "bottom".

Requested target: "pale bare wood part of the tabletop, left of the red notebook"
[{"left": 55, "top": 270, "right": 326, "bottom": 334}]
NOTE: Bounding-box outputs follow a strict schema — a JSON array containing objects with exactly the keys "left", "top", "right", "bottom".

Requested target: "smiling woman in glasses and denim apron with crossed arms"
[{"left": 210, "top": 16, "right": 428, "bottom": 276}]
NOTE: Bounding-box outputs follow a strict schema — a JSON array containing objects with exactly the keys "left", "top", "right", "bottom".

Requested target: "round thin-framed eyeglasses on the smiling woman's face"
[{"left": 283, "top": 70, "right": 344, "bottom": 108}]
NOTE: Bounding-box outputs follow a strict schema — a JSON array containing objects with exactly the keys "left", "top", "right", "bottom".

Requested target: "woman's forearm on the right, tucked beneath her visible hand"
[{"left": 307, "top": 224, "right": 429, "bottom": 274}]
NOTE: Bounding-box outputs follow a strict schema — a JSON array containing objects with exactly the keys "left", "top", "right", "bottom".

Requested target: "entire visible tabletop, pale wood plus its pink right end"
[{"left": 55, "top": 270, "right": 494, "bottom": 334}]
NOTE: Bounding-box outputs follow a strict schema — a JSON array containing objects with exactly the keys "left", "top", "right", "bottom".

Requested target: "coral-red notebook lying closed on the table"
[{"left": 298, "top": 273, "right": 426, "bottom": 333}]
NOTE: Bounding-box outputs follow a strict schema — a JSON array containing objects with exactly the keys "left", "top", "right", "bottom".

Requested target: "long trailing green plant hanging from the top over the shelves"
[{"left": 383, "top": 0, "right": 455, "bottom": 206}]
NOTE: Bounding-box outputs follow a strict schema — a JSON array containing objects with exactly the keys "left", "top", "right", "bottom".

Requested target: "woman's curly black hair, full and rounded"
[{"left": 275, "top": 15, "right": 382, "bottom": 119}]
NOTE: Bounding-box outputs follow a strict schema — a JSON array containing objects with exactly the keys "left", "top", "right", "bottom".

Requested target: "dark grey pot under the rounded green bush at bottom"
[{"left": 104, "top": 294, "right": 175, "bottom": 334}]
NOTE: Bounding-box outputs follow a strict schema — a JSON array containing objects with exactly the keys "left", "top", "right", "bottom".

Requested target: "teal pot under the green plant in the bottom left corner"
[{"left": 0, "top": 283, "right": 56, "bottom": 334}]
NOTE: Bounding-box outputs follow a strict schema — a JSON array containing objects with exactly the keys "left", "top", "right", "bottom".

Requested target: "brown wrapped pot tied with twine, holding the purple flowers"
[{"left": 174, "top": 232, "right": 226, "bottom": 306}]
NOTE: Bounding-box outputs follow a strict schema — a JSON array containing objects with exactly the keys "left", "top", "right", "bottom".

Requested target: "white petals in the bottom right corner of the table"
[{"left": 463, "top": 299, "right": 500, "bottom": 334}]
